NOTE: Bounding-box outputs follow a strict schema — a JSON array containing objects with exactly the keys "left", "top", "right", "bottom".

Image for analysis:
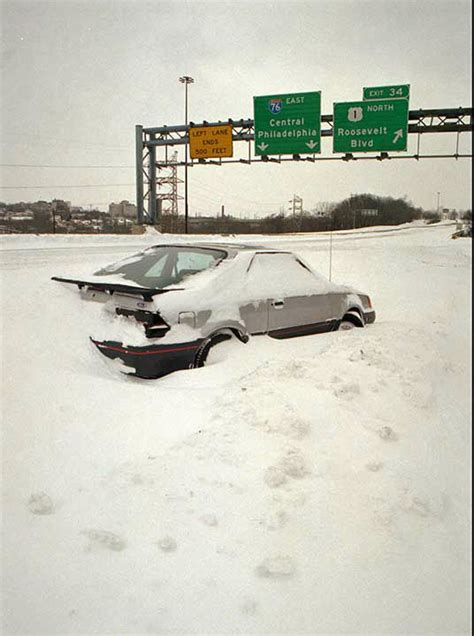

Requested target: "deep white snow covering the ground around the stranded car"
[{"left": 0, "top": 225, "right": 471, "bottom": 635}]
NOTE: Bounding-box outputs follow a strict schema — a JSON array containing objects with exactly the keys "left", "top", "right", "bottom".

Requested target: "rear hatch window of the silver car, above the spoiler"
[{"left": 95, "top": 246, "right": 227, "bottom": 289}]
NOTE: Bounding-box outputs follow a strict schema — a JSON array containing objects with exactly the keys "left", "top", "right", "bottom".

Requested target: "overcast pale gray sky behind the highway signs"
[{"left": 0, "top": 0, "right": 472, "bottom": 216}]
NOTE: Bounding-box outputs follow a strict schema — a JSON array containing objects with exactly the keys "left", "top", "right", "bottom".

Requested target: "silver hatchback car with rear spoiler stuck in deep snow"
[{"left": 53, "top": 243, "right": 375, "bottom": 378}]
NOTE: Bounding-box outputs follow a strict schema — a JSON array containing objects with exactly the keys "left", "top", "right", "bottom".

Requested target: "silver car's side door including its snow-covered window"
[{"left": 248, "top": 252, "right": 333, "bottom": 338}]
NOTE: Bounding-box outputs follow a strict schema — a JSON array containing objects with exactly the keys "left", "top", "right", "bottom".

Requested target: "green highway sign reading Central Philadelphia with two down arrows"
[{"left": 253, "top": 92, "right": 321, "bottom": 155}]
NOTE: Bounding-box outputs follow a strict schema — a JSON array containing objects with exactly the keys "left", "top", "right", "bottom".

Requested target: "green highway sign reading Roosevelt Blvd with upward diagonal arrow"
[{"left": 333, "top": 99, "right": 408, "bottom": 152}]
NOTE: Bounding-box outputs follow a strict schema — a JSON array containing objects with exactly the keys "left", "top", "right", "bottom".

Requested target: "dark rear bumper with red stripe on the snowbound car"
[{"left": 91, "top": 338, "right": 203, "bottom": 379}]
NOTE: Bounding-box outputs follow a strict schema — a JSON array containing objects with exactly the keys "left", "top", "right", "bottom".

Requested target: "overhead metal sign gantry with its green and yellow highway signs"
[{"left": 136, "top": 84, "right": 472, "bottom": 223}]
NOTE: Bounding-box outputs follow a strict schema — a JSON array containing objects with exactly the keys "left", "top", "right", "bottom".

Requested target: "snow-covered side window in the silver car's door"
[{"left": 247, "top": 253, "right": 327, "bottom": 296}]
